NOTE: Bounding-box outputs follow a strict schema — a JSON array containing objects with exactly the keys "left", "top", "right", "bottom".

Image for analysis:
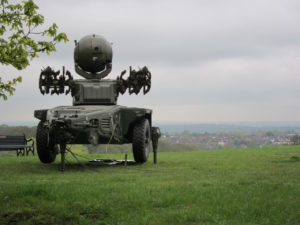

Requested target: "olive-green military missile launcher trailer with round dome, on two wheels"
[{"left": 34, "top": 35, "right": 160, "bottom": 171}]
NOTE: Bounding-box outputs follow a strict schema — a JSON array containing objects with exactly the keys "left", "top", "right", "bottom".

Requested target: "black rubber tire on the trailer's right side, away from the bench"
[{"left": 132, "top": 118, "right": 151, "bottom": 163}]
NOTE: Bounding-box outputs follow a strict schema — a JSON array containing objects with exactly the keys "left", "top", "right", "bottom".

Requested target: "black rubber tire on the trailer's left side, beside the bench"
[{"left": 36, "top": 121, "right": 57, "bottom": 163}]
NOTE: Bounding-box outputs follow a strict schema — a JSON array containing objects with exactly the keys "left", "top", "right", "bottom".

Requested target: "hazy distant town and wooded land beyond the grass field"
[{"left": 0, "top": 123, "right": 300, "bottom": 155}]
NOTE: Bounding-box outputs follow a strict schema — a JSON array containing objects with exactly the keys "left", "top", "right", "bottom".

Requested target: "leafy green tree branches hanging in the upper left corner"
[{"left": 0, "top": 0, "right": 68, "bottom": 100}]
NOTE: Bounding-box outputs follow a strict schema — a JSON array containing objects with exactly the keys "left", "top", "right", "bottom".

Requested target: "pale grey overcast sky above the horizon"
[{"left": 0, "top": 0, "right": 300, "bottom": 122}]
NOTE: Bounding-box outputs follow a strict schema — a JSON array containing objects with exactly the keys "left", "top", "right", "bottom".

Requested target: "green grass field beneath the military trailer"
[{"left": 0, "top": 146, "right": 300, "bottom": 225}]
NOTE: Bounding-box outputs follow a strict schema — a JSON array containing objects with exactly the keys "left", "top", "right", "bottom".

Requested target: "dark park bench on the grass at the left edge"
[{"left": 0, "top": 134, "right": 34, "bottom": 156}]
